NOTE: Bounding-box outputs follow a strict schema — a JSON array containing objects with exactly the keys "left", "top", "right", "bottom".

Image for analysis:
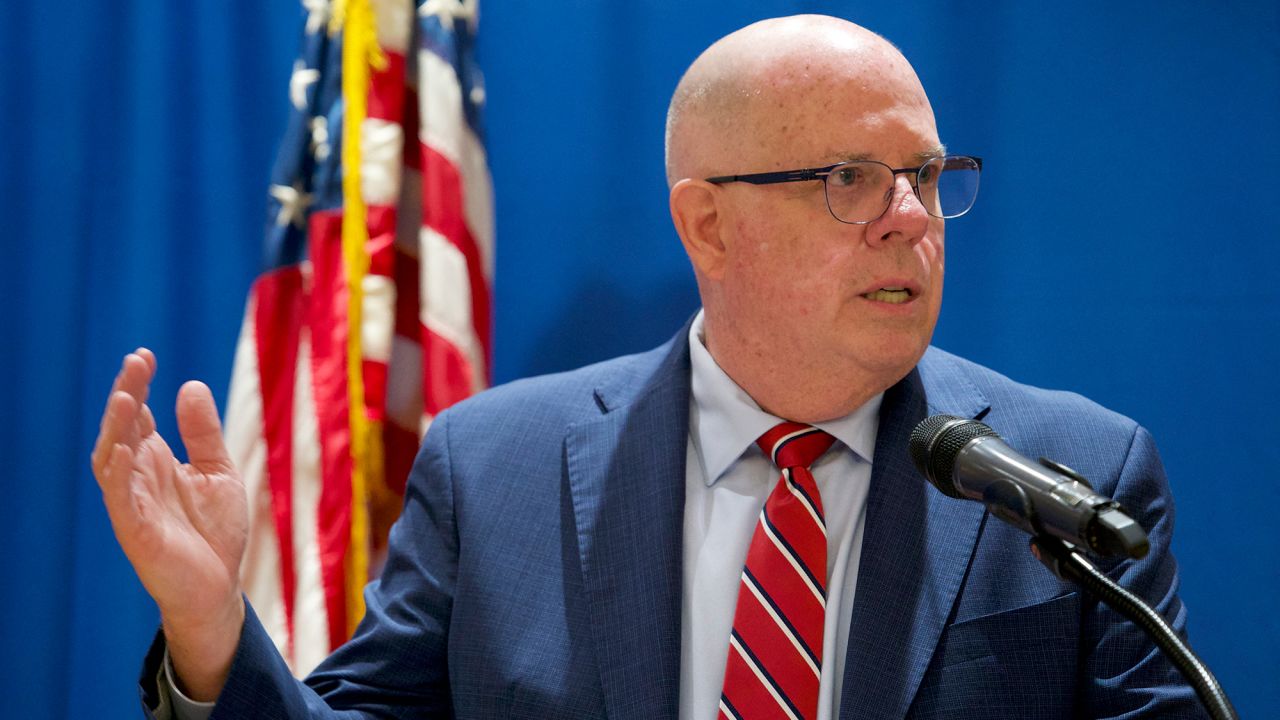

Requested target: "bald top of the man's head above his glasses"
[{"left": 667, "top": 15, "right": 940, "bottom": 182}]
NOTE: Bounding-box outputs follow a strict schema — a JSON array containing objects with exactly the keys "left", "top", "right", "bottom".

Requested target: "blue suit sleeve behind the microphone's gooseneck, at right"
[{"left": 1080, "top": 427, "right": 1207, "bottom": 719}]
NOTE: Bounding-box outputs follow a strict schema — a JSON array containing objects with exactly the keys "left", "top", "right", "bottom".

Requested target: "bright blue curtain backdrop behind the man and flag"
[{"left": 0, "top": 0, "right": 1280, "bottom": 717}]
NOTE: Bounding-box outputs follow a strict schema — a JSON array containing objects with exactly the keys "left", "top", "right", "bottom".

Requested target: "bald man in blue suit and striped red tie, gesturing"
[{"left": 93, "top": 15, "right": 1198, "bottom": 719}]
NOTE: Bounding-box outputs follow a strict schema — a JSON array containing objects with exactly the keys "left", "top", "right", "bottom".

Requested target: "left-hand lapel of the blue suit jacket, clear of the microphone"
[{"left": 564, "top": 327, "right": 689, "bottom": 720}]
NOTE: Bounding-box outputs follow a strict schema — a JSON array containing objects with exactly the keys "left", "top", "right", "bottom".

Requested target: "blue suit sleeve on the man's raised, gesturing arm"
[{"left": 142, "top": 413, "right": 458, "bottom": 720}]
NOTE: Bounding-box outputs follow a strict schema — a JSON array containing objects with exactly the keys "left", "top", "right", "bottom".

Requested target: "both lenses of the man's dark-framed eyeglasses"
[{"left": 827, "top": 155, "right": 979, "bottom": 223}]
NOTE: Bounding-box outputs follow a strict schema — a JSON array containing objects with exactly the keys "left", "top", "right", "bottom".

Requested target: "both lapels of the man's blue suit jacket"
[{"left": 564, "top": 325, "right": 988, "bottom": 720}]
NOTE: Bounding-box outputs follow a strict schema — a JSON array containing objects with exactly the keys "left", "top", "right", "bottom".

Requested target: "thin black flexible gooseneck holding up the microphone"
[{"left": 1030, "top": 533, "right": 1239, "bottom": 720}]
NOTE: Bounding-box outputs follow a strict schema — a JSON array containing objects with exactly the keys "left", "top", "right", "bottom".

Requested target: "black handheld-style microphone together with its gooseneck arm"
[{"left": 909, "top": 415, "right": 1238, "bottom": 720}]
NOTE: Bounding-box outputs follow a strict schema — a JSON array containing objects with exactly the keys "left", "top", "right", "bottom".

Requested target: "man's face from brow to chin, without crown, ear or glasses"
[{"left": 721, "top": 73, "right": 943, "bottom": 387}]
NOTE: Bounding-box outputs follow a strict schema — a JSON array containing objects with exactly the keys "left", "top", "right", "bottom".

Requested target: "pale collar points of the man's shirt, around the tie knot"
[{"left": 689, "top": 311, "right": 884, "bottom": 487}]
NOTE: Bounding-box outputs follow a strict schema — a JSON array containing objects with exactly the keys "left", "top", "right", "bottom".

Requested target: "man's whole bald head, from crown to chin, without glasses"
[{"left": 667, "top": 15, "right": 945, "bottom": 421}]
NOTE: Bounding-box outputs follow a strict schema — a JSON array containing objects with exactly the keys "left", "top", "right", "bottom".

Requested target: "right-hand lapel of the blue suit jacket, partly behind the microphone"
[{"left": 840, "top": 351, "right": 987, "bottom": 720}]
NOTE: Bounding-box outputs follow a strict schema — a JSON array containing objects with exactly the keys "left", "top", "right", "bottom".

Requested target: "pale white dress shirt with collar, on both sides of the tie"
[{"left": 680, "top": 313, "right": 883, "bottom": 720}]
